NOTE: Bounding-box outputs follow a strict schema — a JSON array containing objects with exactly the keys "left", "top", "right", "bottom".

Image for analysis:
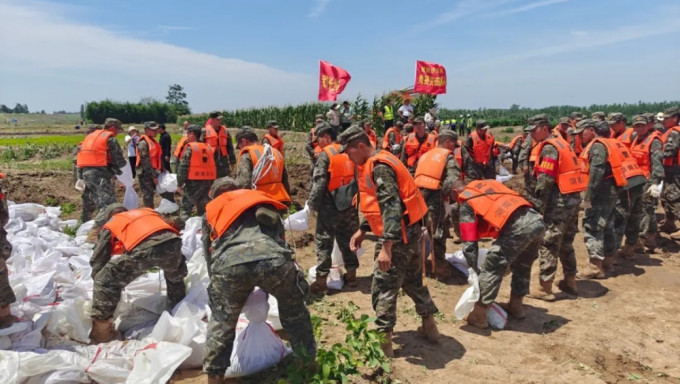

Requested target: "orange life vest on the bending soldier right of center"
[{"left": 458, "top": 180, "right": 531, "bottom": 241}]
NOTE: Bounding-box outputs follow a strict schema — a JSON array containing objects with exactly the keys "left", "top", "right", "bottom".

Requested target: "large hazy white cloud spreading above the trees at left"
[{"left": 0, "top": 1, "right": 316, "bottom": 111}]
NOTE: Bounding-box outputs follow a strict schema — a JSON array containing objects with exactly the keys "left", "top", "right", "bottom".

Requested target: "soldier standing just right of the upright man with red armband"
[{"left": 574, "top": 119, "right": 627, "bottom": 279}]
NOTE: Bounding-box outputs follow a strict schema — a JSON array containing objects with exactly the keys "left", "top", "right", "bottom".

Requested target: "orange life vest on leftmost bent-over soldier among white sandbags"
[{"left": 104, "top": 208, "right": 179, "bottom": 255}]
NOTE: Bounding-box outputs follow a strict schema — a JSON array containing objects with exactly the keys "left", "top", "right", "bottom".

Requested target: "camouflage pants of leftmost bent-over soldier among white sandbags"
[{"left": 92, "top": 238, "right": 187, "bottom": 319}]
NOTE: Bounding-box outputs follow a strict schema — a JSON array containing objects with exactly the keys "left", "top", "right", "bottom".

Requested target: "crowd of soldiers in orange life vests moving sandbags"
[{"left": 0, "top": 102, "right": 680, "bottom": 382}]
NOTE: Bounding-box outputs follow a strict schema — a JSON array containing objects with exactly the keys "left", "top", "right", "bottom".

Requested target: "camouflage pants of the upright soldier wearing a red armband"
[{"left": 538, "top": 204, "right": 579, "bottom": 281}]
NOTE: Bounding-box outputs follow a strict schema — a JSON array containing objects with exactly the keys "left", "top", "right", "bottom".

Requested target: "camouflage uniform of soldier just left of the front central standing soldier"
[{"left": 308, "top": 152, "right": 359, "bottom": 276}]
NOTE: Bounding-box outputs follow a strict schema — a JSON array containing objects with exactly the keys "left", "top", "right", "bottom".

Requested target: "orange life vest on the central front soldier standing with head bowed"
[{"left": 359, "top": 151, "right": 427, "bottom": 243}]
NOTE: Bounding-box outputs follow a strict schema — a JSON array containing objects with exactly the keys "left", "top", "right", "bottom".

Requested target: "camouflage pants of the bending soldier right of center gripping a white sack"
[{"left": 479, "top": 208, "right": 545, "bottom": 305}]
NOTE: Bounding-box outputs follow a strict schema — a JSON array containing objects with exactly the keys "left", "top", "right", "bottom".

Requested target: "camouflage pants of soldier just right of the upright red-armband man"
[{"left": 583, "top": 190, "right": 620, "bottom": 260}]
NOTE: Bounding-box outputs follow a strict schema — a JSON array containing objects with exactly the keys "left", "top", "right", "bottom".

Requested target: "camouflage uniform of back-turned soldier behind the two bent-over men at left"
[{"left": 177, "top": 145, "right": 212, "bottom": 226}]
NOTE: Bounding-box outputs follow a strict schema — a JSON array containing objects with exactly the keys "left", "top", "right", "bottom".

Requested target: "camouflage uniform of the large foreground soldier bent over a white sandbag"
[{"left": 202, "top": 205, "right": 316, "bottom": 375}]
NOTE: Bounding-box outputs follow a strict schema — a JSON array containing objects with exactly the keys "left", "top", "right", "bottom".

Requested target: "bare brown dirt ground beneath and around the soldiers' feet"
[{"left": 5, "top": 158, "right": 680, "bottom": 384}]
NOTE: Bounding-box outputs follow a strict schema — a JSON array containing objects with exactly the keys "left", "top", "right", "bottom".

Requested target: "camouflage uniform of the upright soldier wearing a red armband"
[{"left": 534, "top": 138, "right": 581, "bottom": 281}]
